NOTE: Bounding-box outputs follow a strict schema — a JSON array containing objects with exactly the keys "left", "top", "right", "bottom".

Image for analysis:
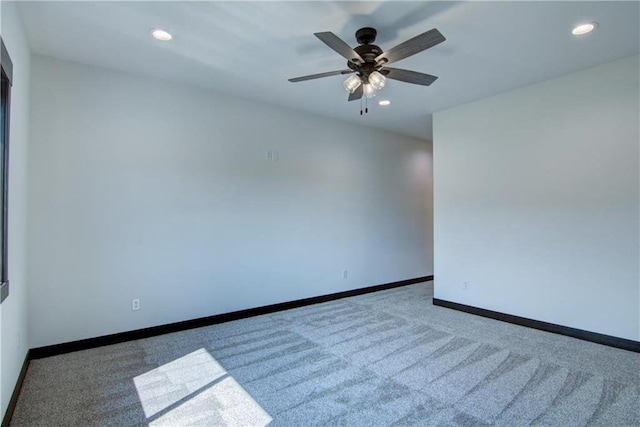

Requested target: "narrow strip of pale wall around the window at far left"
[{"left": 0, "top": 2, "right": 30, "bottom": 416}]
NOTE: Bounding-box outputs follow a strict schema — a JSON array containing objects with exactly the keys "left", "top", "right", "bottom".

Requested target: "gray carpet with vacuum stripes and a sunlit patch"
[{"left": 11, "top": 282, "right": 640, "bottom": 426}]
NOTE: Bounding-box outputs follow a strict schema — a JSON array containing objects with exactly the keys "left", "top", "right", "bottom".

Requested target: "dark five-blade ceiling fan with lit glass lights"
[{"left": 289, "top": 27, "right": 446, "bottom": 110}]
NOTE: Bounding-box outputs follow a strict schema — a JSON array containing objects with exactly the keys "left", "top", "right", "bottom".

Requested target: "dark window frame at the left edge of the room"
[{"left": 0, "top": 37, "right": 13, "bottom": 304}]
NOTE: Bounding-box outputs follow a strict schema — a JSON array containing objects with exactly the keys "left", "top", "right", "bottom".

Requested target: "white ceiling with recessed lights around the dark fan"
[{"left": 13, "top": 1, "right": 640, "bottom": 139}]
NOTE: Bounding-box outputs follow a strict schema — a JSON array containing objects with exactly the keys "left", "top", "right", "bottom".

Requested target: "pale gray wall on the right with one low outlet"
[{"left": 434, "top": 56, "right": 640, "bottom": 340}]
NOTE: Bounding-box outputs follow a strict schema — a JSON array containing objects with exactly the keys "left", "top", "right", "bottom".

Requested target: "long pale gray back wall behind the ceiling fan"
[{"left": 29, "top": 56, "right": 433, "bottom": 347}]
